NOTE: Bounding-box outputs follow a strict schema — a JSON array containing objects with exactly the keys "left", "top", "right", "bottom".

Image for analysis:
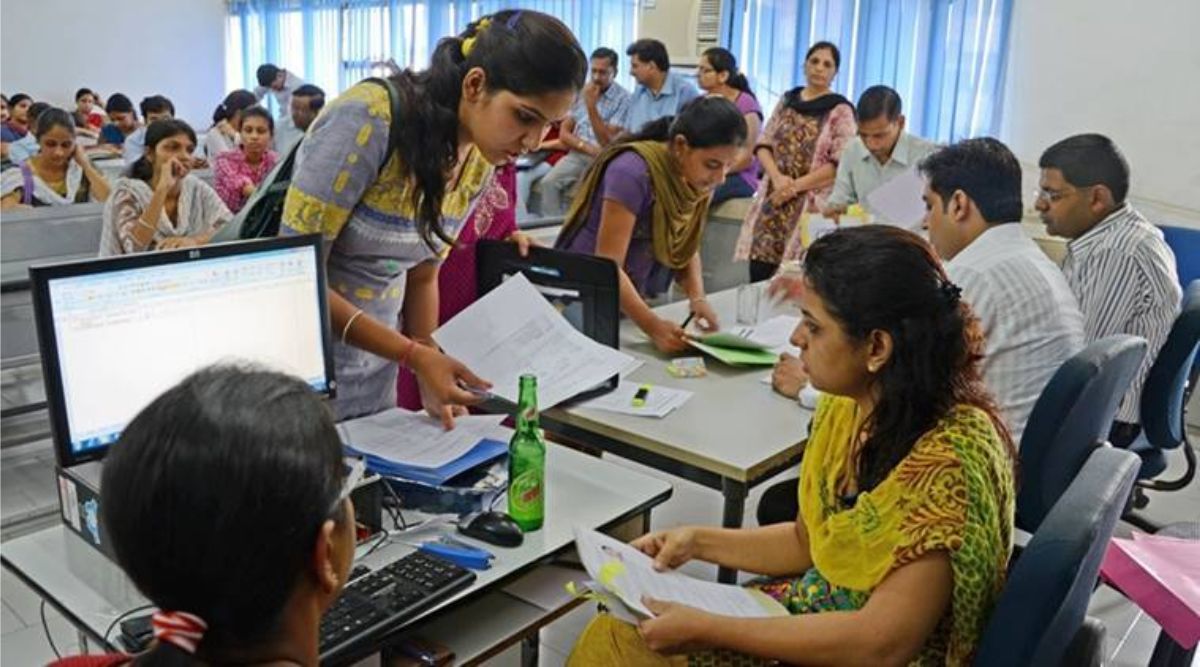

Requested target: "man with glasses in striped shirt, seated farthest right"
[{"left": 1037, "top": 134, "right": 1182, "bottom": 446}]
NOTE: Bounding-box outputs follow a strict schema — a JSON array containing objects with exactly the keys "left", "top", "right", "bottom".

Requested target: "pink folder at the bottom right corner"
[{"left": 1100, "top": 533, "right": 1200, "bottom": 649}]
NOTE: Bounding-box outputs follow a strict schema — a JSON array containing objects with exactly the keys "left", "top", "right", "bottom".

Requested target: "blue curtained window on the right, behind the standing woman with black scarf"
[{"left": 725, "top": 0, "right": 1013, "bottom": 142}]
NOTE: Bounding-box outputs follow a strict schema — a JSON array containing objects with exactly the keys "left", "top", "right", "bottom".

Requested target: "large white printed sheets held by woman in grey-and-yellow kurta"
[{"left": 433, "top": 274, "right": 641, "bottom": 410}]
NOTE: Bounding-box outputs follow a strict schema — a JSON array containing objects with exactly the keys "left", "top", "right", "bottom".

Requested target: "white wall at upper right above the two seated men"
[{"left": 1001, "top": 0, "right": 1200, "bottom": 227}]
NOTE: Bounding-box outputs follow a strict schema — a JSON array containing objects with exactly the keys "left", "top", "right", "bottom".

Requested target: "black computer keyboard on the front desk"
[{"left": 320, "top": 552, "right": 475, "bottom": 662}]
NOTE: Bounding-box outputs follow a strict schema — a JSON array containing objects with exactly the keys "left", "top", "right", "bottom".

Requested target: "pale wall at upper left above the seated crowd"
[{"left": 0, "top": 0, "right": 226, "bottom": 131}]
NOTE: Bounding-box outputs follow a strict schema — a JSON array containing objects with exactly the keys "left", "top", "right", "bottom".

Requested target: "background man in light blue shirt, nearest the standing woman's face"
[{"left": 535, "top": 47, "right": 630, "bottom": 216}]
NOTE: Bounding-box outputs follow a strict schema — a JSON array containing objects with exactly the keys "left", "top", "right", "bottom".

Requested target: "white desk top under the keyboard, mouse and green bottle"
[{"left": 0, "top": 445, "right": 671, "bottom": 657}]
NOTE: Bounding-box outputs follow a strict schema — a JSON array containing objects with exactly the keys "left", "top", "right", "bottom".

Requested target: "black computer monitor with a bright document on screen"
[{"left": 29, "top": 234, "right": 336, "bottom": 468}]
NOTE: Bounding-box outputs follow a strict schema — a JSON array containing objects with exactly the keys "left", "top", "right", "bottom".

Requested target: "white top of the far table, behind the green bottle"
[{"left": 546, "top": 289, "right": 812, "bottom": 482}]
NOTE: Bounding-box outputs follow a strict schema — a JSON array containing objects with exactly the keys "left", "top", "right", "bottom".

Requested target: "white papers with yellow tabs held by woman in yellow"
[{"left": 575, "top": 525, "right": 787, "bottom": 623}]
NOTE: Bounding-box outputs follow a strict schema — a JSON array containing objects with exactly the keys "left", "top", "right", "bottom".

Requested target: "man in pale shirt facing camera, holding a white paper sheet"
[{"left": 823, "top": 85, "right": 937, "bottom": 224}]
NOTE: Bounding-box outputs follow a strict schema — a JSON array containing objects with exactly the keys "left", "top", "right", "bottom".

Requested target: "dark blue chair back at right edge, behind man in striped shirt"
[{"left": 1140, "top": 280, "right": 1200, "bottom": 450}]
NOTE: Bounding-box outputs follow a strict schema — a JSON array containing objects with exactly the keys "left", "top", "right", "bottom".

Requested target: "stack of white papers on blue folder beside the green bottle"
[{"left": 338, "top": 408, "right": 509, "bottom": 486}]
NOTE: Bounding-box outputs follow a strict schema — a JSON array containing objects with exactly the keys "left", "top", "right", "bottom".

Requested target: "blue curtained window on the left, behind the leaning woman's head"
[{"left": 226, "top": 0, "right": 637, "bottom": 113}]
